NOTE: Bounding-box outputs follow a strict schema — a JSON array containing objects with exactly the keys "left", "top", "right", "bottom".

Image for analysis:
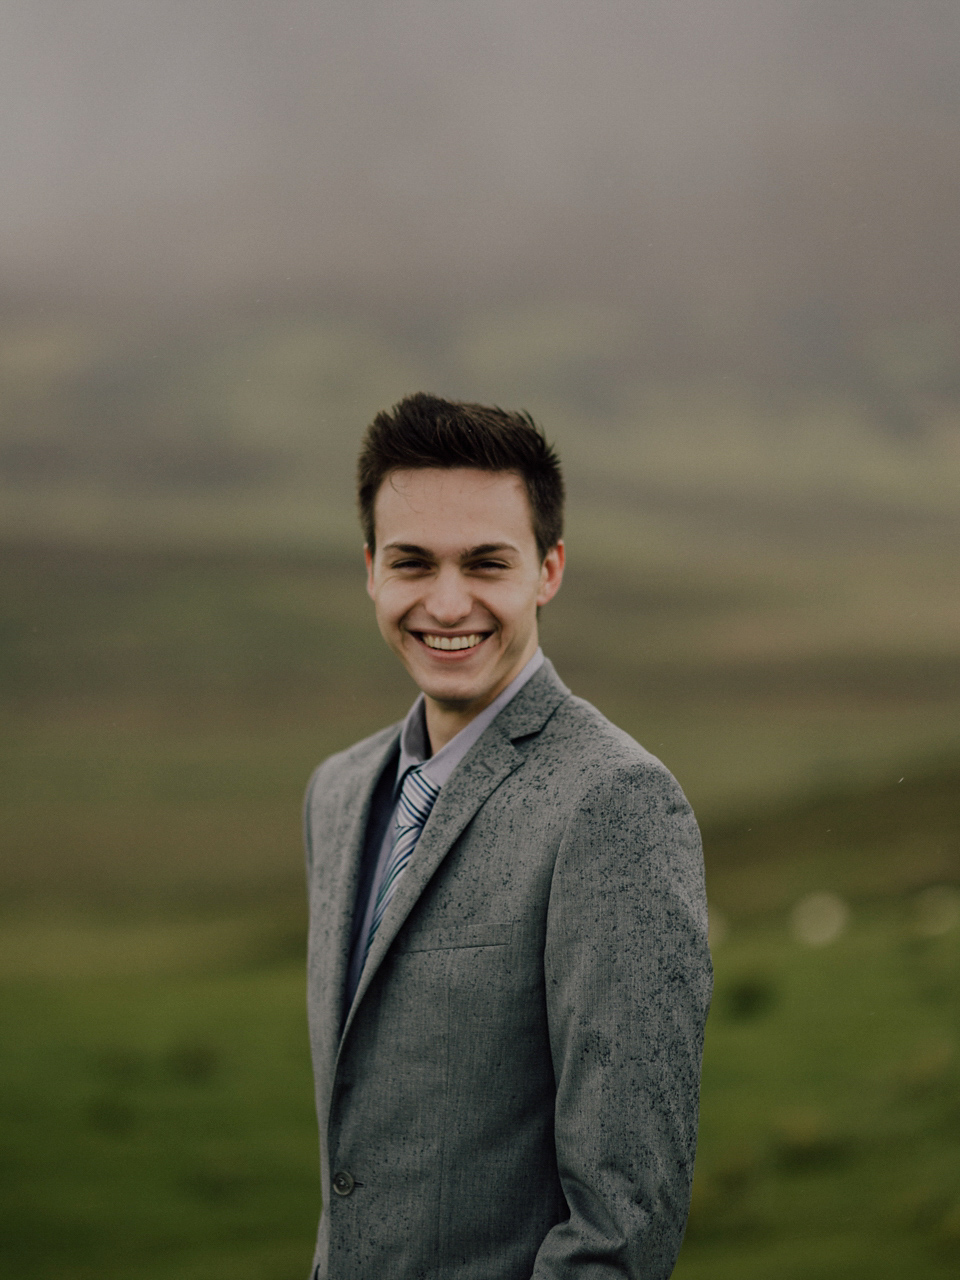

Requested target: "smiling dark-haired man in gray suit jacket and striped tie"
[{"left": 306, "top": 394, "right": 710, "bottom": 1280}]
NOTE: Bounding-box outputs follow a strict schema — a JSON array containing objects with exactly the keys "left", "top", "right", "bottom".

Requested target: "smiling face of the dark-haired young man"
[{"left": 366, "top": 467, "right": 563, "bottom": 714}]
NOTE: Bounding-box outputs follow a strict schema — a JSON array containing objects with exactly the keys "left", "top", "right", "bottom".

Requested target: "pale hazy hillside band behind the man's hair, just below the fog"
[{"left": 0, "top": 302, "right": 960, "bottom": 563}]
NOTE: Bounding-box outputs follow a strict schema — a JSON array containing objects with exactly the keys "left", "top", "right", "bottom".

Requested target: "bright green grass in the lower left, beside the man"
[{"left": 0, "top": 961, "right": 319, "bottom": 1280}]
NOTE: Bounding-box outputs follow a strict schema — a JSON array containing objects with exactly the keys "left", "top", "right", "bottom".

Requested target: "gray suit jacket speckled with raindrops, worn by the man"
[{"left": 306, "top": 663, "right": 710, "bottom": 1280}]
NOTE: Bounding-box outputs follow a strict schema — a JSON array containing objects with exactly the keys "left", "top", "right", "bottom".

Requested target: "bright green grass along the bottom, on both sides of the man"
[{"left": 0, "top": 900, "right": 960, "bottom": 1280}]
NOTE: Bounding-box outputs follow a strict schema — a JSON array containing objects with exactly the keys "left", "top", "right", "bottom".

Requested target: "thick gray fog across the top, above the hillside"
[{"left": 0, "top": 0, "right": 960, "bottom": 379}]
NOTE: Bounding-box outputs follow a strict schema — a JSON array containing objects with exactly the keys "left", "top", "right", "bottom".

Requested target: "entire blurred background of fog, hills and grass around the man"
[{"left": 0, "top": 0, "right": 960, "bottom": 1280}]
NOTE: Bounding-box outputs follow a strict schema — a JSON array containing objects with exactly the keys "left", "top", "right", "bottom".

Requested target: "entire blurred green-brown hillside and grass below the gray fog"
[{"left": 0, "top": 307, "right": 960, "bottom": 1280}]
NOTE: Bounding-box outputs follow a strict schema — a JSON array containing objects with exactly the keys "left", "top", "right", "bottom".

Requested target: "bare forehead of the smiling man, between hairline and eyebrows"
[{"left": 374, "top": 467, "right": 534, "bottom": 549}]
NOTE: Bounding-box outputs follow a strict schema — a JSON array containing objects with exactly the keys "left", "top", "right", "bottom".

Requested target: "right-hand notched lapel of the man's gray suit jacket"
[{"left": 340, "top": 662, "right": 570, "bottom": 1043}]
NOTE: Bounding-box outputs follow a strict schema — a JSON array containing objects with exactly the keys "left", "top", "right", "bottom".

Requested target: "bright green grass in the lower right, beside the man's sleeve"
[{"left": 677, "top": 906, "right": 960, "bottom": 1280}]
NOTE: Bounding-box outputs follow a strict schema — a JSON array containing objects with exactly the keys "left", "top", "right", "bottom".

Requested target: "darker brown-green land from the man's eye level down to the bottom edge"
[{"left": 0, "top": 541, "right": 960, "bottom": 1280}]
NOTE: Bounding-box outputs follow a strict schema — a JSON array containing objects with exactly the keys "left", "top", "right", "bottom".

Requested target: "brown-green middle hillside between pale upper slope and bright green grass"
[{"left": 0, "top": 544, "right": 960, "bottom": 905}]
